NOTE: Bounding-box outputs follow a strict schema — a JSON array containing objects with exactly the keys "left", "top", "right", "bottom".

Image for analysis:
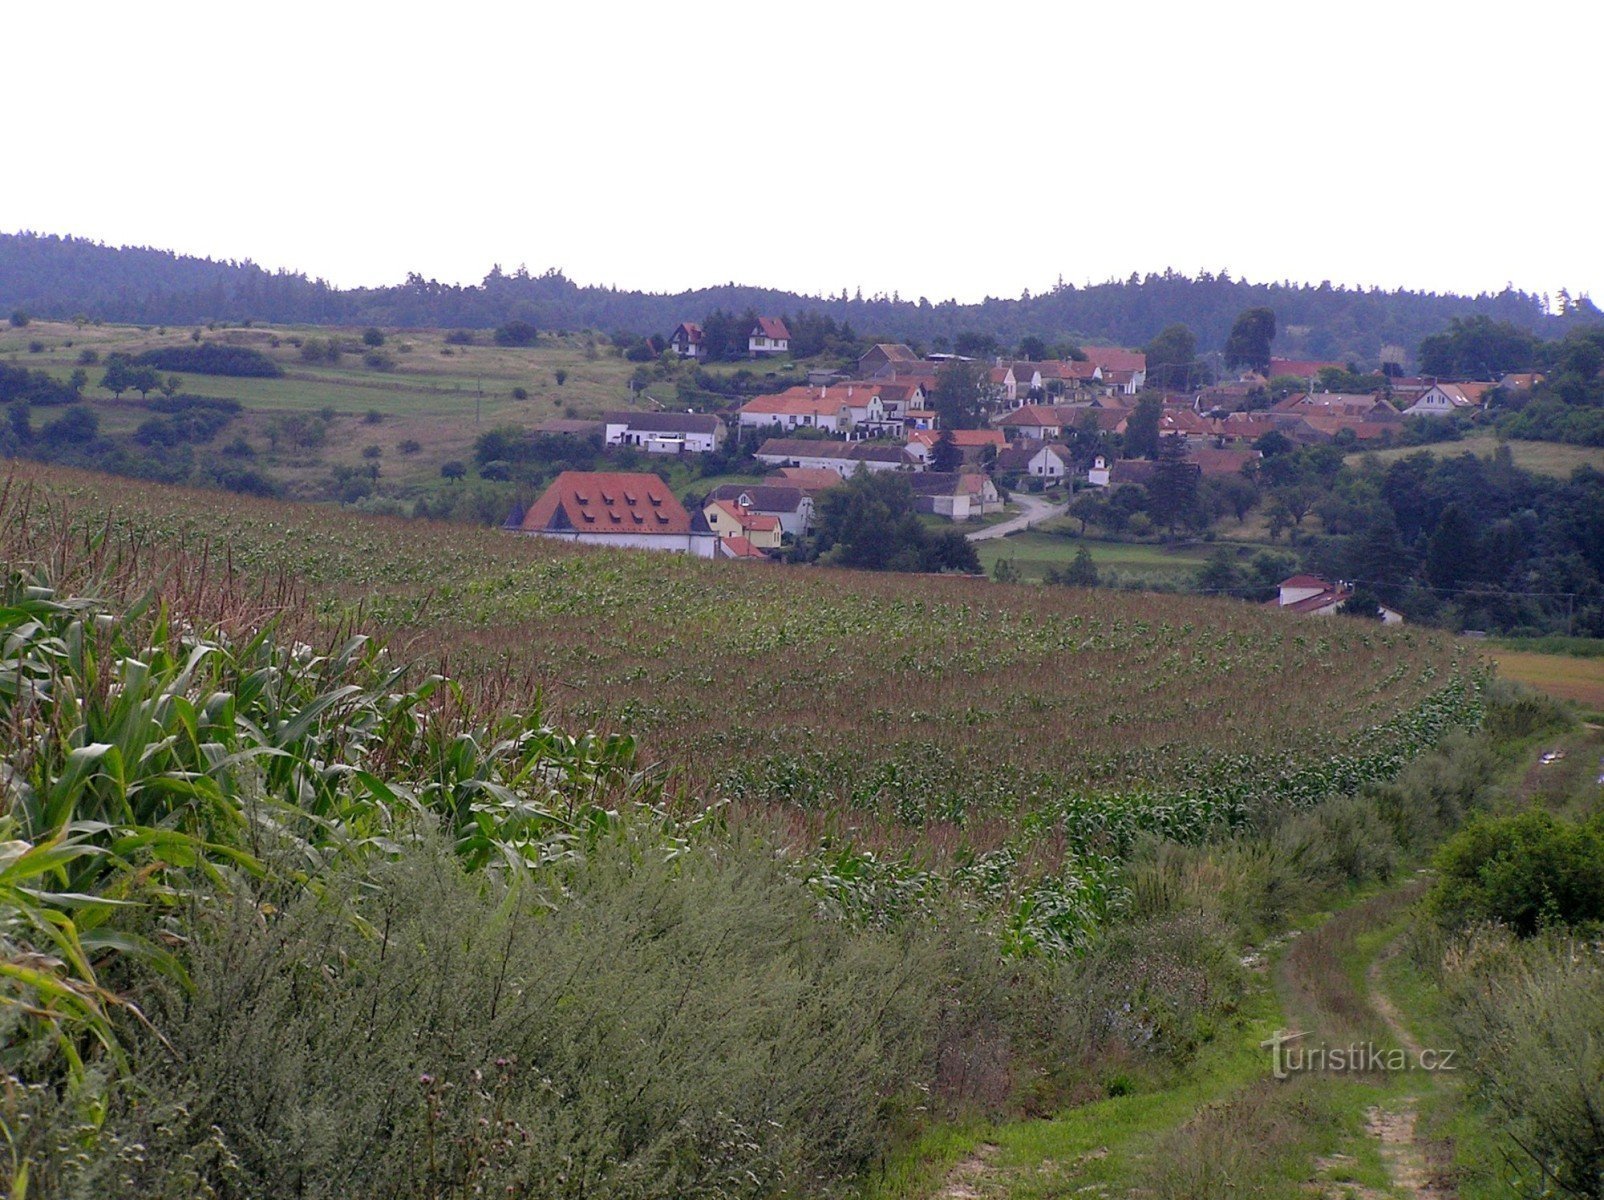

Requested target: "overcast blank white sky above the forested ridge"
[{"left": 0, "top": 0, "right": 1604, "bottom": 300}]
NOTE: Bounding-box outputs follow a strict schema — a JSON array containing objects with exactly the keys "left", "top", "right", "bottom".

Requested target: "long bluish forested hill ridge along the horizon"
[{"left": 0, "top": 233, "right": 1601, "bottom": 361}]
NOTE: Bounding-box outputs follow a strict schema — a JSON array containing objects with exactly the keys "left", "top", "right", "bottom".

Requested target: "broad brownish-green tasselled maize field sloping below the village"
[{"left": 8, "top": 467, "right": 1472, "bottom": 837}]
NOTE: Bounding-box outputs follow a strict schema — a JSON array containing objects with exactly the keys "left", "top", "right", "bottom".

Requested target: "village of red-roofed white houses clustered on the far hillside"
[{"left": 484, "top": 318, "right": 1540, "bottom": 622}]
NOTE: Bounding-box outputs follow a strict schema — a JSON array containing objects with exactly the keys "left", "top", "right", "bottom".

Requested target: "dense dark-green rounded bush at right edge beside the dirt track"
[{"left": 1431, "top": 812, "right": 1604, "bottom": 937}]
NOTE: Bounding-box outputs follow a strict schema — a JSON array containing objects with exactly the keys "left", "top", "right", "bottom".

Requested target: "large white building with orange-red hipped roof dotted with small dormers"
[{"left": 507, "top": 470, "right": 719, "bottom": 558}]
